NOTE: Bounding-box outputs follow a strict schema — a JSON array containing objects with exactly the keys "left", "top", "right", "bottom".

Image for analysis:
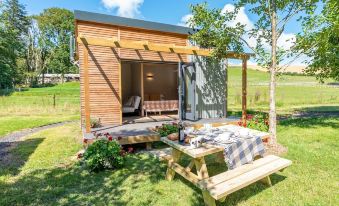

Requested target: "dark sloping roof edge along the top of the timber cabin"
[{"left": 74, "top": 10, "right": 194, "bottom": 35}]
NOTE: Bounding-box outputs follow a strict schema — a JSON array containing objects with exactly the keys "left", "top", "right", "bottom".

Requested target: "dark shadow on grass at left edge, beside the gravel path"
[{"left": 0, "top": 138, "right": 44, "bottom": 176}]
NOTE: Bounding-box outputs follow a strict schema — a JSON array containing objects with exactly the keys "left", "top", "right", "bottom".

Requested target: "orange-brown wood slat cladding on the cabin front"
[{"left": 76, "top": 21, "right": 187, "bottom": 125}]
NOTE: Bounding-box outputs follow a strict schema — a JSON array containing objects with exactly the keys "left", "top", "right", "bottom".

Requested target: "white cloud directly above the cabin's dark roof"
[{"left": 101, "top": 0, "right": 144, "bottom": 17}]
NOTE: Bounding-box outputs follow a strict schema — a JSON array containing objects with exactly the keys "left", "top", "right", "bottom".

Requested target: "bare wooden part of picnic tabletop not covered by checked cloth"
[{"left": 160, "top": 137, "right": 224, "bottom": 158}]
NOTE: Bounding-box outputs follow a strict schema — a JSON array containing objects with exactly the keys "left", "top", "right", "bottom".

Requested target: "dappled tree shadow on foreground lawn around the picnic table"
[{"left": 0, "top": 145, "right": 285, "bottom": 206}]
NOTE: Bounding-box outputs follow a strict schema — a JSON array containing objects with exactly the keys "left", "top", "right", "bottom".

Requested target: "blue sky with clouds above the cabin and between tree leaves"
[{"left": 19, "top": 0, "right": 314, "bottom": 65}]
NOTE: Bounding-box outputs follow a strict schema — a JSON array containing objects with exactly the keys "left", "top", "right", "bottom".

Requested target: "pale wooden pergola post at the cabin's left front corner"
[{"left": 83, "top": 44, "right": 91, "bottom": 133}]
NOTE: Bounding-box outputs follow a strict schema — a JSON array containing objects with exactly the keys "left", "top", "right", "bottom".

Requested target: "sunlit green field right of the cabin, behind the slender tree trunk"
[{"left": 228, "top": 67, "right": 339, "bottom": 114}]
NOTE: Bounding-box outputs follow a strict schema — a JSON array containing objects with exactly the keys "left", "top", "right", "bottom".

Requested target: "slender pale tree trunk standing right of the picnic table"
[{"left": 269, "top": 0, "right": 277, "bottom": 144}]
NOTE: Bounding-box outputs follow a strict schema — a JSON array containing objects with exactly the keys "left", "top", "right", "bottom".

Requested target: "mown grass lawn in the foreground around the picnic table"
[{"left": 0, "top": 118, "right": 339, "bottom": 206}]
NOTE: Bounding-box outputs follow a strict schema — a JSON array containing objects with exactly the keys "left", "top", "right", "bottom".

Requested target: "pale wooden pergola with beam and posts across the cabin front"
[{"left": 77, "top": 34, "right": 252, "bottom": 133}]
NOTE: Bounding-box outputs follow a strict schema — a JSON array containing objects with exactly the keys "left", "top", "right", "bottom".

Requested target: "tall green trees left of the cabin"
[{"left": 0, "top": 3, "right": 77, "bottom": 89}]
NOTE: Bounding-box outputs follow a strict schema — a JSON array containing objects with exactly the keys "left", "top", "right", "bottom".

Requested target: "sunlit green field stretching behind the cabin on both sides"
[{"left": 0, "top": 67, "right": 339, "bottom": 136}]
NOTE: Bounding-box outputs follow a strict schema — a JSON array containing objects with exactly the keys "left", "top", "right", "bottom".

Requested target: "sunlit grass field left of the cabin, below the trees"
[{"left": 0, "top": 82, "right": 80, "bottom": 137}]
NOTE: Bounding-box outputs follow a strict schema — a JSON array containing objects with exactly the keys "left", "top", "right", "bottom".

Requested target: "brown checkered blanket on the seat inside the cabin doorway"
[{"left": 144, "top": 100, "right": 179, "bottom": 112}]
